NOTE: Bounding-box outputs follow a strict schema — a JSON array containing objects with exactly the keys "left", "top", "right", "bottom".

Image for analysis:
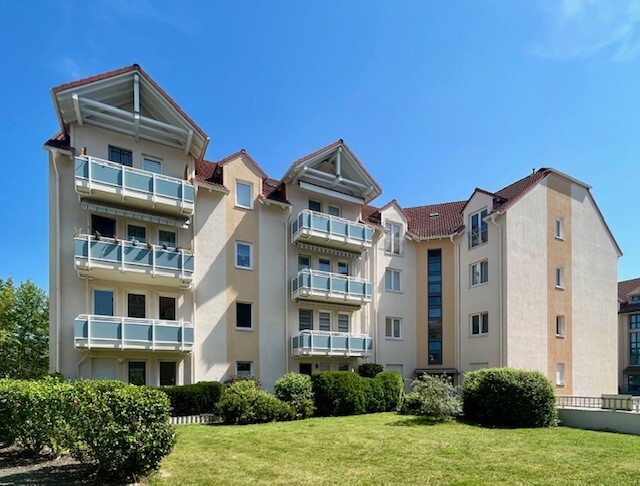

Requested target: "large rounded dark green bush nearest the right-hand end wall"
[{"left": 462, "top": 368, "right": 557, "bottom": 427}]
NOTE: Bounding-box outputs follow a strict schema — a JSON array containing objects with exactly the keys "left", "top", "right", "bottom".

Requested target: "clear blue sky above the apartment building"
[{"left": 0, "top": 0, "right": 640, "bottom": 288}]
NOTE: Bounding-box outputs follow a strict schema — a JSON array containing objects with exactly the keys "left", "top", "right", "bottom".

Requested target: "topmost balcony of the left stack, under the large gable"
[{"left": 75, "top": 156, "right": 195, "bottom": 216}]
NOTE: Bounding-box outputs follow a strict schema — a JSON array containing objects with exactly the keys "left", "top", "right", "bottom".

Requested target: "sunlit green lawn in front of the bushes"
[{"left": 150, "top": 413, "right": 640, "bottom": 485}]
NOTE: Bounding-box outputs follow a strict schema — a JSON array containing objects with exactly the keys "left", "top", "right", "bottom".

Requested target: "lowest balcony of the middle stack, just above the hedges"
[{"left": 291, "top": 330, "right": 373, "bottom": 358}]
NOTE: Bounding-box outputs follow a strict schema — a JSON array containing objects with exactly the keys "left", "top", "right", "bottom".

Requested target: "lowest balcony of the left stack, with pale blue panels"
[{"left": 74, "top": 314, "right": 193, "bottom": 352}]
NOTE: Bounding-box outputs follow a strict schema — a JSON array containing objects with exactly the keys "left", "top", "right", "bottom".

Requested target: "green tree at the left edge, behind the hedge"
[{"left": 0, "top": 278, "right": 49, "bottom": 379}]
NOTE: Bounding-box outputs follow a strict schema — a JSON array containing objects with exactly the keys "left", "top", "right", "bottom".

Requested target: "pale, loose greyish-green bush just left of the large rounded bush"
[{"left": 400, "top": 374, "right": 462, "bottom": 422}]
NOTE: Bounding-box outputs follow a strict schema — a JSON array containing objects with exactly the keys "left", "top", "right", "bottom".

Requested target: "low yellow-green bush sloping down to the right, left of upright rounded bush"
[{"left": 218, "top": 380, "right": 296, "bottom": 425}]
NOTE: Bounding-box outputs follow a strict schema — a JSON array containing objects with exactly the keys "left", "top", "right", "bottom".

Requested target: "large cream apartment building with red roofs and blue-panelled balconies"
[{"left": 45, "top": 65, "right": 621, "bottom": 394}]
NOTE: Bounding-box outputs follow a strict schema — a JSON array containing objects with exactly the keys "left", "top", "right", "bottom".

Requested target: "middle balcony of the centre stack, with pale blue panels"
[{"left": 291, "top": 269, "right": 373, "bottom": 305}]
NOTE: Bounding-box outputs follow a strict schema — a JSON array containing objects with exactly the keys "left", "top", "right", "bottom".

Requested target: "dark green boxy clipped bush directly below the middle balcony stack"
[{"left": 311, "top": 371, "right": 367, "bottom": 417}]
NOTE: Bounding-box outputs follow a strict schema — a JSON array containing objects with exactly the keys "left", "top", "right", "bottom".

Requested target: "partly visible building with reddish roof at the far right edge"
[{"left": 618, "top": 278, "right": 640, "bottom": 395}]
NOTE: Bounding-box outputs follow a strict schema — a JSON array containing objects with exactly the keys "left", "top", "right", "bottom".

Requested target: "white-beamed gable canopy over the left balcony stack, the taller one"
[{"left": 52, "top": 64, "right": 209, "bottom": 160}]
